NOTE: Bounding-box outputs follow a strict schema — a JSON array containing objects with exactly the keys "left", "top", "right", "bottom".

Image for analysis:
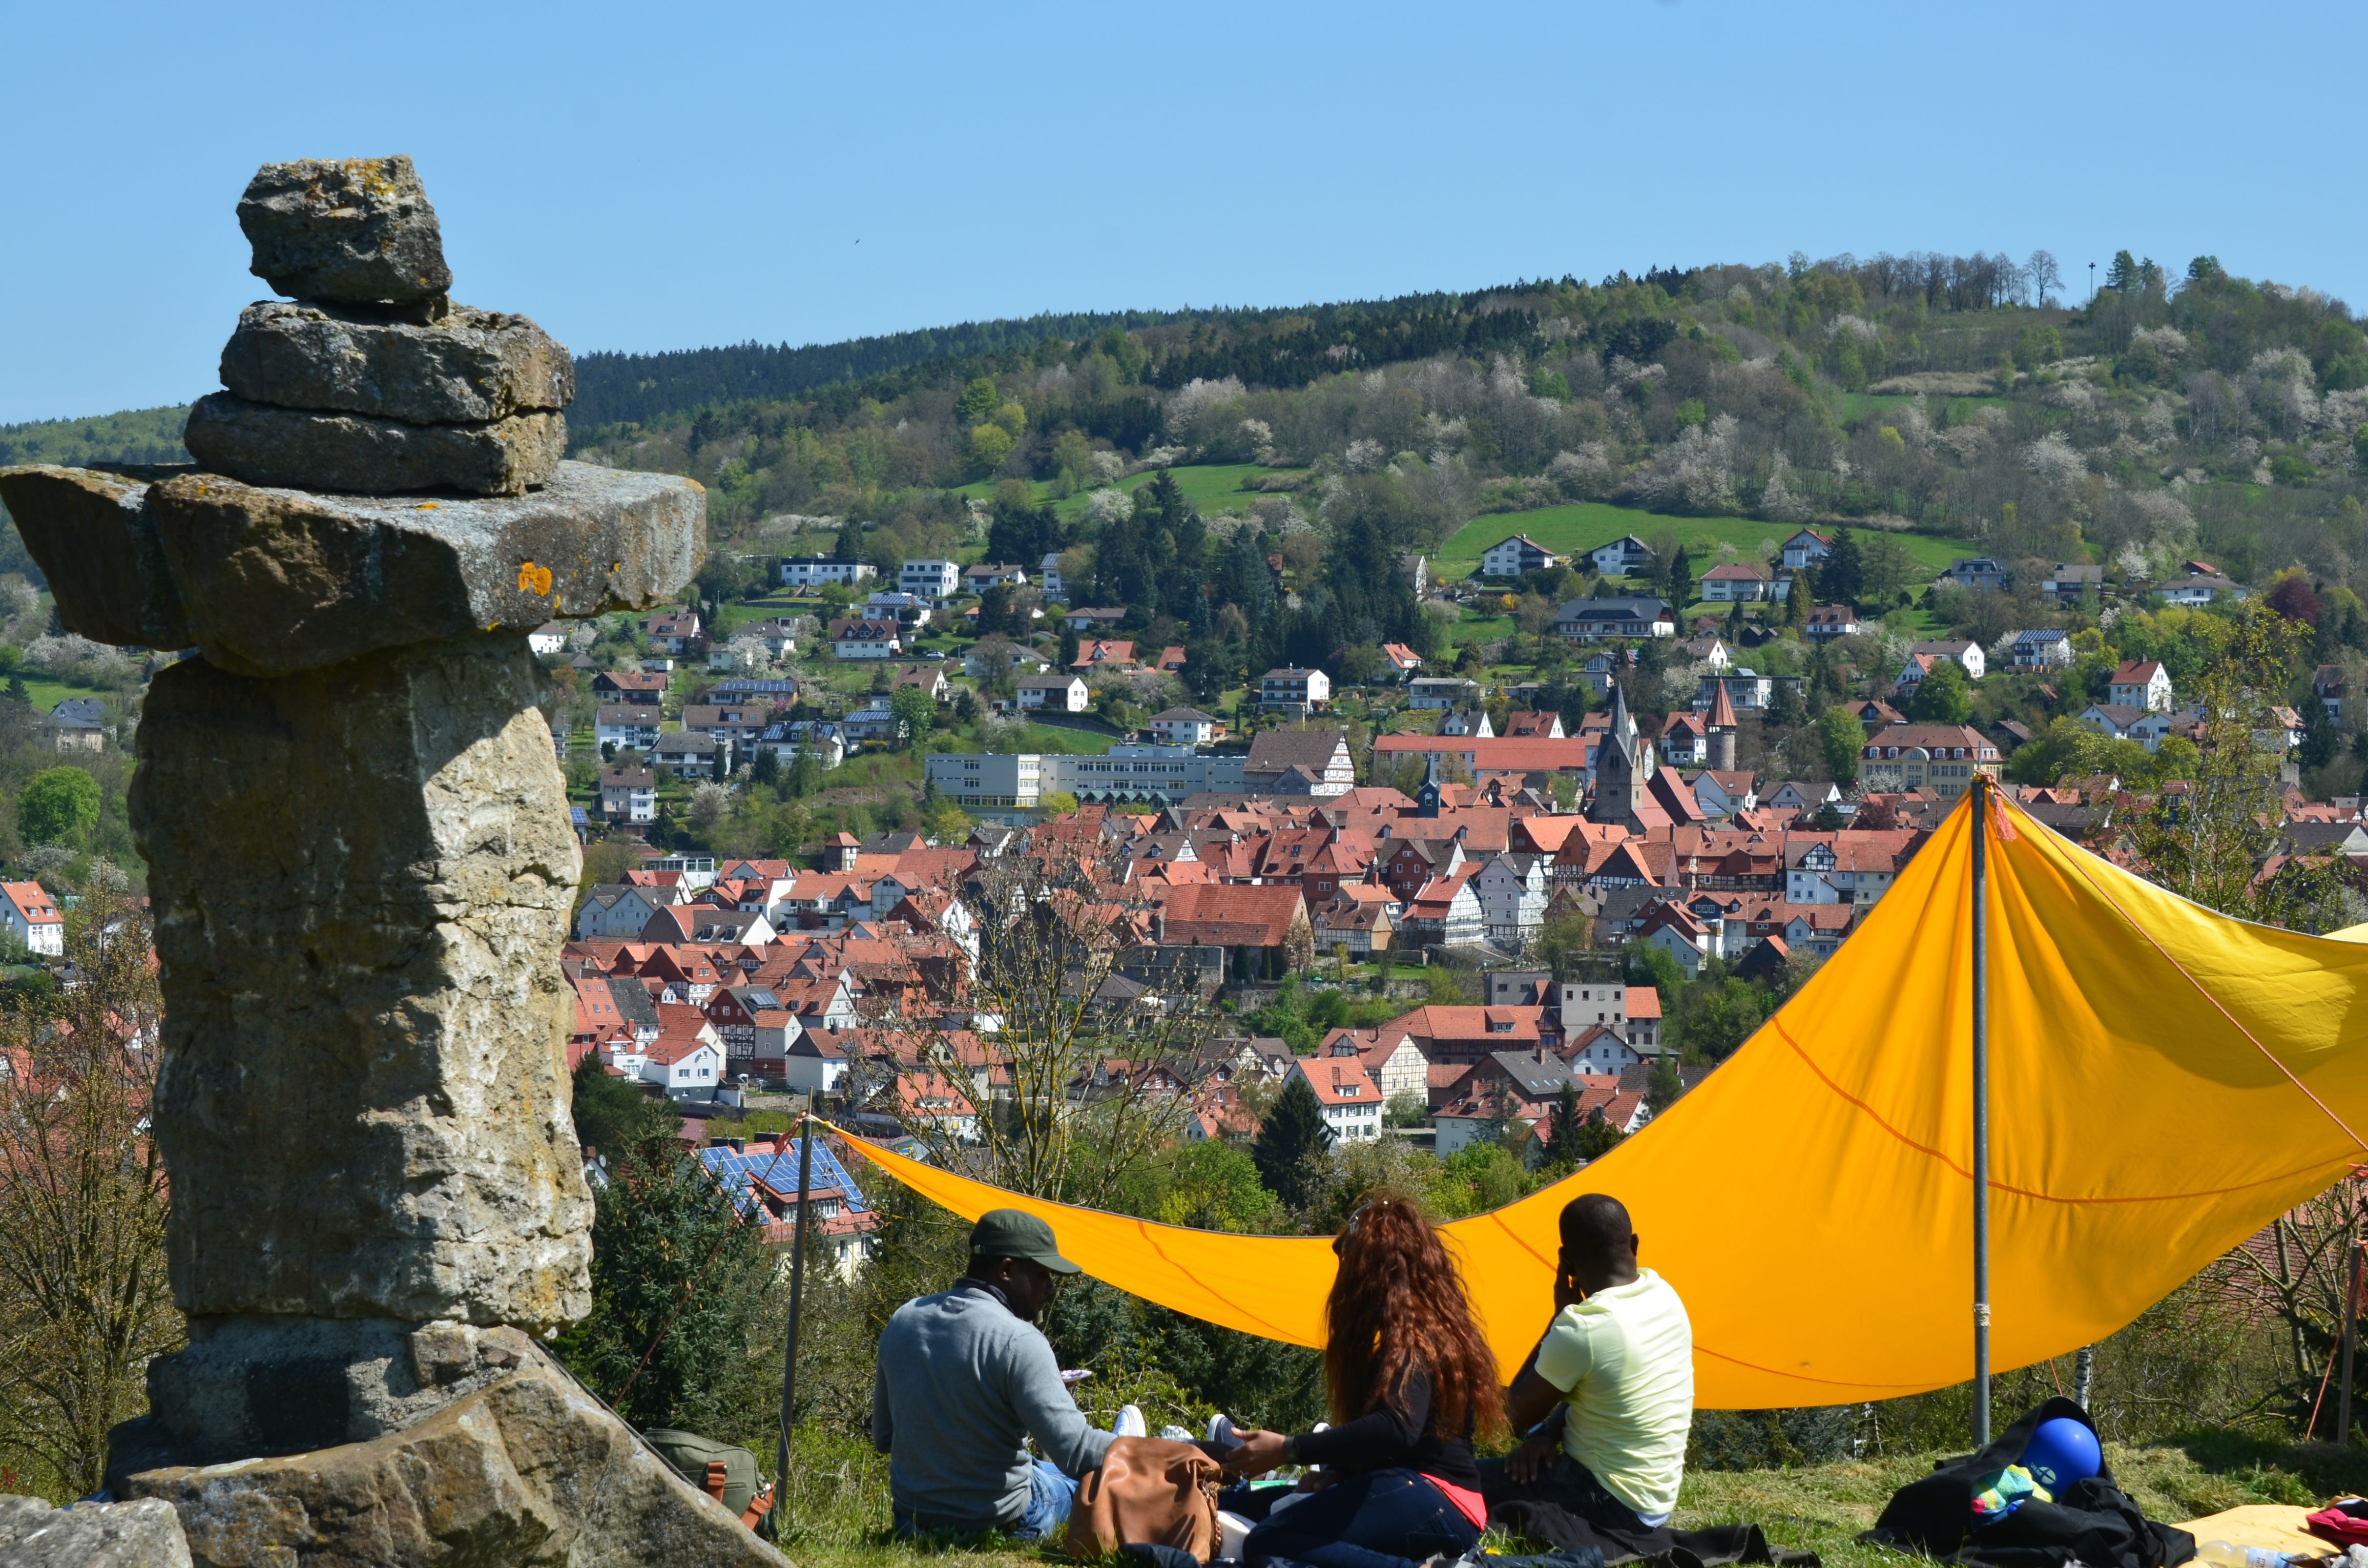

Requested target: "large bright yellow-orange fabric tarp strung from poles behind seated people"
[{"left": 829, "top": 801, "right": 2368, "bottom": 1409}]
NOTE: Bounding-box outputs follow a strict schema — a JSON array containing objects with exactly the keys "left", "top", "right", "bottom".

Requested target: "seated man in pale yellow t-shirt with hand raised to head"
[{"left": 1480, "top": 1192, "right": 1693, "bottom": 1530}]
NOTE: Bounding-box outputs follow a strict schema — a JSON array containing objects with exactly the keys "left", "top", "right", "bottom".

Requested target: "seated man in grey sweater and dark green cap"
[{"left": 872, "top": 1208, "right": 1111, "bottom": 1540}]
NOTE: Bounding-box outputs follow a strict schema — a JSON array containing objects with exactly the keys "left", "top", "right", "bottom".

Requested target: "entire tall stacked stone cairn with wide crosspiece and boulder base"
[{"left": 0, "top": 156, "right": 782, "bottom": 1568}]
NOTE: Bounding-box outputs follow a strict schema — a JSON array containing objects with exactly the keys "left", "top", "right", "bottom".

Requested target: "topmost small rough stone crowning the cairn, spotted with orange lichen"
[{"left": 239, "top": 154, "right": 452, "bottom": 306}]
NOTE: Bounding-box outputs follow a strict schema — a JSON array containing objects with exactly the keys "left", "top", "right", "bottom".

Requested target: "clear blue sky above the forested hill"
[{"left": 0, "top": 0, "right": 2368, "bottom": 422}]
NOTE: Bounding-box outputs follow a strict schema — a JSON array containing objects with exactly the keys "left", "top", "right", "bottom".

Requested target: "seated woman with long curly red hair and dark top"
[{"left": 1226, "top": 1196, "right": 1504, "bottom": 1568}]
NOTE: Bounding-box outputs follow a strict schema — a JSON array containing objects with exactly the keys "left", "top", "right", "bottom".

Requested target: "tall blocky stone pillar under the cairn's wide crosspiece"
[{"left": 130, "top": 644, "right": 590, "bottom": 1329}]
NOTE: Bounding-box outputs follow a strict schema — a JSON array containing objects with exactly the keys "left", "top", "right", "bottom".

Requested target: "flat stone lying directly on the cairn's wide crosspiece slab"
[{"left": 180, "top": 393, "right": 568, "bottom": 495}]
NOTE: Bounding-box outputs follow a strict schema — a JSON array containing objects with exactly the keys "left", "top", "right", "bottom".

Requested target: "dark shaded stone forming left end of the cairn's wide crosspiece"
[{"left": 0, "top": 464, "right": 197, "bottom": 649}]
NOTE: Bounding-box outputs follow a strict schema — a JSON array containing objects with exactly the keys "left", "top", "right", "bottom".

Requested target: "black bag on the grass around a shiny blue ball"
[{"left": 1859, "top": 1398, "right": 2195, "bottom": 1568}]
